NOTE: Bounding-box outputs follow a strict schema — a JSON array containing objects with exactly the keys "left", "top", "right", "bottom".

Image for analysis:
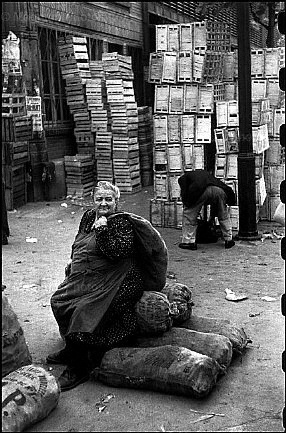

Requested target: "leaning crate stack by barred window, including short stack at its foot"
[{"left": 58, "top": 35, "right": 95, "bottom": 196}]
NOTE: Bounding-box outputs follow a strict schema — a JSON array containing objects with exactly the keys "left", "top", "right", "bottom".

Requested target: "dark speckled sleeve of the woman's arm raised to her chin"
[{"left": 95, "top": 217, "right": 134, "bottom": 260}]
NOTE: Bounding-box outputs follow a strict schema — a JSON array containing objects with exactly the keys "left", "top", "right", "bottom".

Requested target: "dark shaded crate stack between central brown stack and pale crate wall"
[{"left": 138, "top": 106, "right": 153, "bottom": 186}]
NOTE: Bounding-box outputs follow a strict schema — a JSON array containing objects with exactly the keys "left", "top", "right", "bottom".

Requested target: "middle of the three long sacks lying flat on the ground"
[{"left": 134, "top": 328, "right": 232, "bottom": 368}]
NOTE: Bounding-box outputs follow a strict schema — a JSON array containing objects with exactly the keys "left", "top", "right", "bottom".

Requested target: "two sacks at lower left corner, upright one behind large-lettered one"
[{"left": 2, "top": 288, "right": 60, "bottom": 433}]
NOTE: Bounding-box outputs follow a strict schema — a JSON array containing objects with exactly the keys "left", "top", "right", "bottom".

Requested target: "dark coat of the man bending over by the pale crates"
[{"left": 178, "top": 170, "right": 236, "bottom": 207}]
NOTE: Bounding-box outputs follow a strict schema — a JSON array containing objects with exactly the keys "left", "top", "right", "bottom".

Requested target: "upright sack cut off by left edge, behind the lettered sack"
[{"left": 2, "top": 293, "right": 32, "bottom": 377}]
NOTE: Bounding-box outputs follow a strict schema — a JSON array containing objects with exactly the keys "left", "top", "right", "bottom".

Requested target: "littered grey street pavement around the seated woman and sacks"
[{"left": 2, "top": 187, "right": 285, "bottom": 432}]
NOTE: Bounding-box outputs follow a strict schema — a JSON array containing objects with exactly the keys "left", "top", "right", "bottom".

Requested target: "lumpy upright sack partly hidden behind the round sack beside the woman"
[{"left": 161, "top": 281, "right": 194, "bottom": 326}]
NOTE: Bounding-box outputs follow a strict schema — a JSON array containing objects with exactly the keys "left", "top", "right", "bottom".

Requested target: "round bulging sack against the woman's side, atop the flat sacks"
[{"left": 135, "top": 291, "right": 172, "bottom": 335}]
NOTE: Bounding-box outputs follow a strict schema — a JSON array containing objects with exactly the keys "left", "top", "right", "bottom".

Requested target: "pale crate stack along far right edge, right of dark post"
[{"left": 252, "top": 47, "right": 285, "bottom": 221}]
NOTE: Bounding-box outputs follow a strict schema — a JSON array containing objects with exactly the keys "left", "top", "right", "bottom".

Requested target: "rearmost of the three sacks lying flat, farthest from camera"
[{"left": 178, "top": 315, "right": 251, "bottom": 353}]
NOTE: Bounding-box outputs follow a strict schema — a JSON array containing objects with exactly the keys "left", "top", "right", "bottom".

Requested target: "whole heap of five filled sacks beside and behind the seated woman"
[{"left": 92, "top": 280, "right": 250, "bottom": 398}]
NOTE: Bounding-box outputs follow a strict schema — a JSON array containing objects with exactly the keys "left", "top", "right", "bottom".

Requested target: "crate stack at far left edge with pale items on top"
[{"left": 2, "top": 32, "right": 32, "bottom": 210}]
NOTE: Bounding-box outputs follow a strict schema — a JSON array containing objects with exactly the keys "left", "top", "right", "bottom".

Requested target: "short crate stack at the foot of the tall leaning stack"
[{"left": 64, "top": 154, "right": 94, "bottom": 198}]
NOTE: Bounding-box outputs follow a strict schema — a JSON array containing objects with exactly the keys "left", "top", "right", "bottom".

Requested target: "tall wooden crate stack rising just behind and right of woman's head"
[{"left": 102, "top": 53, "right": 142, "bottom": 193}]
